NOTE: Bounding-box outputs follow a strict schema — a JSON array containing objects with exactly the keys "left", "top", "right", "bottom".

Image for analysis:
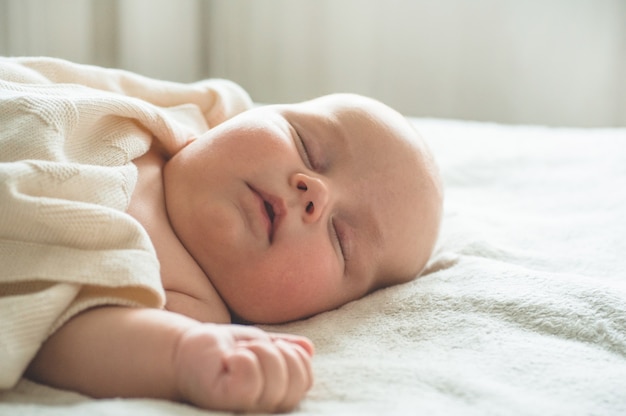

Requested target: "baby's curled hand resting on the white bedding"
[{"left": 174, "top": 324, "right": 313, "bottom": 412}]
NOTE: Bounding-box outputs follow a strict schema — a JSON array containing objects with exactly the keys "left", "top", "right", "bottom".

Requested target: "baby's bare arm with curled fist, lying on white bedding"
[{"left": 27, "top": 307, "right": 313, "bottom": 411}]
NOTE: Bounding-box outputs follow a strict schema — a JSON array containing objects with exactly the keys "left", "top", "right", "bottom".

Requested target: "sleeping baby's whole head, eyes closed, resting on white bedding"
[{"left": 164, "top": 94, "right": 442, "bottom": 323}]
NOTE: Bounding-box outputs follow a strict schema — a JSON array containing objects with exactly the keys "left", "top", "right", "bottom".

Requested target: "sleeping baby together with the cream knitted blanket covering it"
[{"left": 0, "top": 58, "right": 442, "bottom": 411}]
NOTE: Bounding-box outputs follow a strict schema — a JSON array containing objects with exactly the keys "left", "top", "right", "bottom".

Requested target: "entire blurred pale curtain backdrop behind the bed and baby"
[{"left": 0, "top": 0, "right": 626, "bottom": 127}]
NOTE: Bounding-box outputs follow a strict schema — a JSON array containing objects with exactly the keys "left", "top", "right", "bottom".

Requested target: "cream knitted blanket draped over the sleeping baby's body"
[{"left": 0, "top": 58, "right": 251, "bottom": 389}]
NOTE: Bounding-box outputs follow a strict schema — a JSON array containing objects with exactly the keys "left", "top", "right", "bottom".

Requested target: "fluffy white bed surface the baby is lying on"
[{"left": 0, "top": 118, "right": 626, "bottom": 416}]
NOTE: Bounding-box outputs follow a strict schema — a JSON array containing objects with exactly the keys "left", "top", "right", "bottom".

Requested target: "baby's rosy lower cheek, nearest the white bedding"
[{"left": 227, "top": 245, "right": 341, "bottom": 323}]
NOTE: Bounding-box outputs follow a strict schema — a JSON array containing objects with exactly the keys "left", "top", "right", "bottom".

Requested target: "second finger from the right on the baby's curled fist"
[{"left": 241, "top": 341, "right": 289, "bottom": 412}]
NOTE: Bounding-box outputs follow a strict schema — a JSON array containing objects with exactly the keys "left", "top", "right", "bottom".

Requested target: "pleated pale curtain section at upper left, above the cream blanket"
[{"left": 0, "top": 0, "right": 208, "bottom": 81}]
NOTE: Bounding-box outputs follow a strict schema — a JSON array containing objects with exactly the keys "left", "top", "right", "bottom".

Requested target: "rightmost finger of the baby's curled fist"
[{"left": 276, "top": 339, "right": 313, "bottom": 412}]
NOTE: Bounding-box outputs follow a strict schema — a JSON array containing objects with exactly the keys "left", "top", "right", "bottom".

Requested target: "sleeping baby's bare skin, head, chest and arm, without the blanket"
[{"left": 1, "top": 58, "right": 442, "bottom": 411}]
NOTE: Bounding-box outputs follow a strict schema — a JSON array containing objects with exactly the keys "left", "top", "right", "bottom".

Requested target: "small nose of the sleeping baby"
[{"left": 290, "top": 173, "right": 328, "bottom": 223}]
